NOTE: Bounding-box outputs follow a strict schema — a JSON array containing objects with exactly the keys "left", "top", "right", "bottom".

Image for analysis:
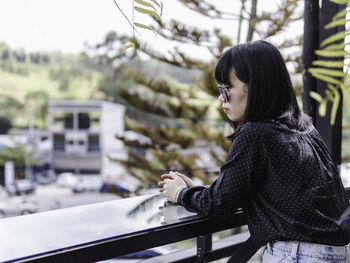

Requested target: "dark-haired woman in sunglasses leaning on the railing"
[{"left": 158, "top": 41, "right": 350, "bottom": 263}]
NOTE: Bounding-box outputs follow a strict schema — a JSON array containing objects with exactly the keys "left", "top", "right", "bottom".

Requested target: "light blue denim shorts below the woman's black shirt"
[{"left": 263, "top": 241, "right": 350, "bottom": 263}]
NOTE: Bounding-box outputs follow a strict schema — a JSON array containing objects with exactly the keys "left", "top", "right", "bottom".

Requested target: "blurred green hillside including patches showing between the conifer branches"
[{"left": 0, "top": 42, "right": 199, "bottom": 133}]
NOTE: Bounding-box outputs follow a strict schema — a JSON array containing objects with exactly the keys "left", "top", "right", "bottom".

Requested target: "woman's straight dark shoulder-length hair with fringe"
[{"left": 215, "top": 40, "right": 311, "bottom": 130}]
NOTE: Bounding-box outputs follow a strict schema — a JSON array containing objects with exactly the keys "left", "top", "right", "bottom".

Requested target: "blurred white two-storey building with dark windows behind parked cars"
[{"left": 49, "top": 100, "right": 126, "bottom": 183}]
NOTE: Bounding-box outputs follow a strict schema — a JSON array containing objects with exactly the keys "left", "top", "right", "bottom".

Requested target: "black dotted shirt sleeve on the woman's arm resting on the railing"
[{"left": 178, "top": 125, "right": 265, "bottom": 220}]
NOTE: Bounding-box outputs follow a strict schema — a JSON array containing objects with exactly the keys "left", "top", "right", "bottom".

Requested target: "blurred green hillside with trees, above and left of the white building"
[{"left": 0, "top": 43, "right": 101, "bottom": 128}]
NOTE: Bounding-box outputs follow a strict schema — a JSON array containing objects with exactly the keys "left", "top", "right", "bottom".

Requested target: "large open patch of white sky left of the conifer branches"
[{"left": 0, "top": 0, "right": 133, "bottom": 52}]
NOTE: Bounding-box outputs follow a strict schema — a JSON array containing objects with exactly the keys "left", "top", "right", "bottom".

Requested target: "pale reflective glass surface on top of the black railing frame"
[{"left": 0, "top": 194, "right": 200, "bottom": 262}]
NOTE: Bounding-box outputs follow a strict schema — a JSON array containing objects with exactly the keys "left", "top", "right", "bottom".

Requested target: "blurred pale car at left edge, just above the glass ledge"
[{"left": 0, "top": 197, "right": 39, "bottom": 216}]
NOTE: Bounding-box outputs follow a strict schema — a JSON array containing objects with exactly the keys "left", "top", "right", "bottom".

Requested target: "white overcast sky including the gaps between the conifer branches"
[{"left": 0, "top": 0, "right": 300, "bottom": 59}]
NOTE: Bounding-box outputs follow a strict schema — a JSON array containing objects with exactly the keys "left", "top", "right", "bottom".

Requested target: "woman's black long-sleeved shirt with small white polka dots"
[{"left": 177, "top": 121, "right": 350, "bottom": 246}]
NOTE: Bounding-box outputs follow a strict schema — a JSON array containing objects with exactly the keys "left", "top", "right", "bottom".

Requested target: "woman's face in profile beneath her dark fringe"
[{"left": 219, "top": 70, "right": 248, "bottom": 121}]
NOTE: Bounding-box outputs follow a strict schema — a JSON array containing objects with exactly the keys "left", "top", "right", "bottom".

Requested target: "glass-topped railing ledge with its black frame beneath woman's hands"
[{"left": 0, "top": 194, "right": 244, "bottom": 263}]
